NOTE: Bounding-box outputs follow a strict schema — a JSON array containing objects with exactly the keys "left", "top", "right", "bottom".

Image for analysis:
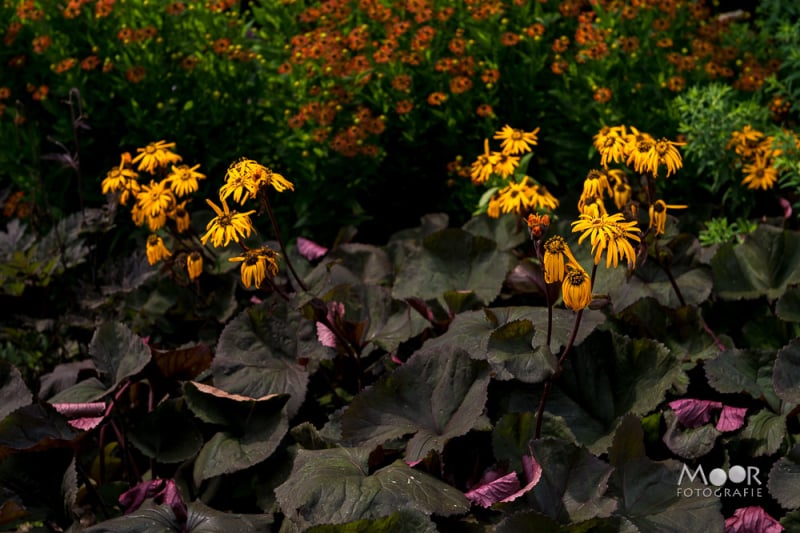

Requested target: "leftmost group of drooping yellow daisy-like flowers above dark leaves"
[{"left": 101, "top": 141, "right": 294, "bottom": 287}]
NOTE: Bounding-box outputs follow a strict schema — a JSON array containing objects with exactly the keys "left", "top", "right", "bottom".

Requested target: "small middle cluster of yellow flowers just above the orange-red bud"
[{"left": 469, "top": 125, "right": 558, "bottom": 218}]
